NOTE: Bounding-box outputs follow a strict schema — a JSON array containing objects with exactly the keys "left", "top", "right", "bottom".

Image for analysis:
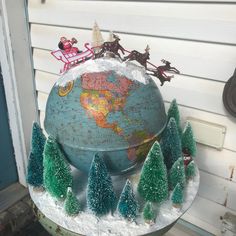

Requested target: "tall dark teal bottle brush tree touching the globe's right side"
[{"left": 160, "top": 117, "right": 182, "bottom": 170}]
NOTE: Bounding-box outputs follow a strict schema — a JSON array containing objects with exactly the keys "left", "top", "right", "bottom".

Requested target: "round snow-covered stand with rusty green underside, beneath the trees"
[{"left": 29, "top": 169, "right": 200, "bottom": 236}]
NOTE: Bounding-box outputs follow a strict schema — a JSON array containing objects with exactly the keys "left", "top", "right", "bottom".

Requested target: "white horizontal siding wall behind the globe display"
[{"left": 29, "top": 0, "right": 236, "bottom": 235}]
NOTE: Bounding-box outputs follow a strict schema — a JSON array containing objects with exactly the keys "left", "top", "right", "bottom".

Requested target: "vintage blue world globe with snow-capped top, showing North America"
[{"left": 44, "top": 58, "right": 167, "bottom": 175}]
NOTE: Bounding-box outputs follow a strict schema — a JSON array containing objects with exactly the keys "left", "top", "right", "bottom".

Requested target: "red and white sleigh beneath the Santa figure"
[{"left": 51, "top": 43, "right": 94, "bottom": 73}]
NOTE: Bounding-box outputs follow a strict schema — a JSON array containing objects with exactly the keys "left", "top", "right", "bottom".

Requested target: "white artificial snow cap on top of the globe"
[{"left": 56, "top": 58, "right": 150, "bottom": 86}]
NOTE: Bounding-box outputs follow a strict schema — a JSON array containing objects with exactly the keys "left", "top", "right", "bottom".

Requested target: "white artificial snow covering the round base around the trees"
[{"left": 30, "top": 171, "right": 200, "bottom": 236}]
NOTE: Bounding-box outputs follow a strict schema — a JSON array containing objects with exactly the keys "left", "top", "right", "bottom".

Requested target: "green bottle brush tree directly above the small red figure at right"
[{"left": 182, "top": 122, "right": 196, "bottom": 156}]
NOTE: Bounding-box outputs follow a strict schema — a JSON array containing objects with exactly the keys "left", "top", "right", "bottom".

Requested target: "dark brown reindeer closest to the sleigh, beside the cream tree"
[{"left": 95, "top": 34, "right": 125, "bottom": 59}]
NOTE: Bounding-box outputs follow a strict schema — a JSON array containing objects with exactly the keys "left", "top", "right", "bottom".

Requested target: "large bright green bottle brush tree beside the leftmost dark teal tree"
[{"left": 43, "top": 136, "right": 72, "bottom": 199}]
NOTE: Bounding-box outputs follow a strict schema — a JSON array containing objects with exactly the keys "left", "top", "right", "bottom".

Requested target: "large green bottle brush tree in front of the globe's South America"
[{"left": 138, "top": 141, "right": 168, "bottom": 202}]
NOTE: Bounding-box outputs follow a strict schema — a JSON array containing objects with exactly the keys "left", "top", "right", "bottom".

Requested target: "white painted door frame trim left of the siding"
[{"left": 0, "top": 0, "right": 38, "bottom": 186}]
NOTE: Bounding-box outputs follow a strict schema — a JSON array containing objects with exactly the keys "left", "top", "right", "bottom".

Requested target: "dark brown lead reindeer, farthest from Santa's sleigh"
[{"left": 147, "top": 59, "right": 180, "bottom": 86}]
